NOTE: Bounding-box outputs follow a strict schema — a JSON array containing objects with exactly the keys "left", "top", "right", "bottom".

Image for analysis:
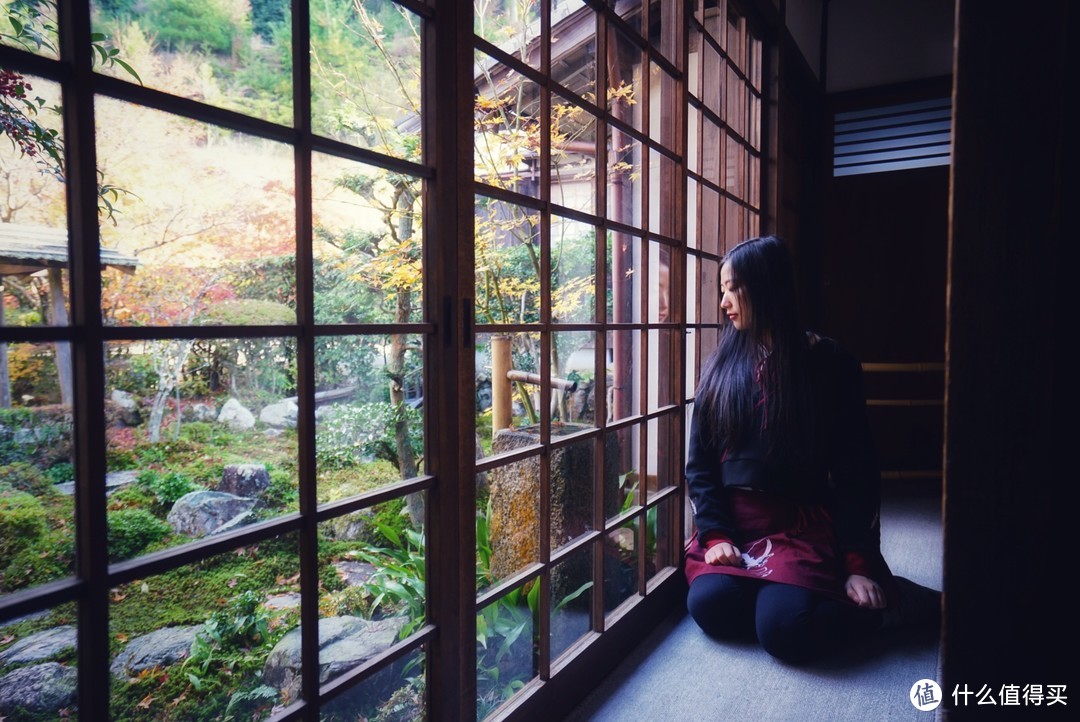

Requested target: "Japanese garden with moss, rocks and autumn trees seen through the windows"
[{"left": 0, "top": 0, "right": 659, "bottom": 722}]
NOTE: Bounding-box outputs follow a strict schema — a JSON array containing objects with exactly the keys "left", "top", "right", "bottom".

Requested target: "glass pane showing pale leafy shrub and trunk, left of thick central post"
[{"left": 315, "top": 333, "right": 424, "bottom": 503}]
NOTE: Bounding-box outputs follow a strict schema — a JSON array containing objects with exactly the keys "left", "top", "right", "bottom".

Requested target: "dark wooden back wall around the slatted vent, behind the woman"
[{"left": 815, "top": 85, "right": 951, "bottom": 493}]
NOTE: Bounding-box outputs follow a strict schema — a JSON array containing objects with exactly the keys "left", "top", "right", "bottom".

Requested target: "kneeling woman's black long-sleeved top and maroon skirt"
[{"left": 685, "top": 339, "right": 892, "bottom": 601}]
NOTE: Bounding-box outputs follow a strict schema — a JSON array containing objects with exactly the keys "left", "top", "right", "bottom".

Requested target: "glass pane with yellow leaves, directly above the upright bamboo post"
[{"left": 474, "top": 195, "right": 540, "bottom": 324}]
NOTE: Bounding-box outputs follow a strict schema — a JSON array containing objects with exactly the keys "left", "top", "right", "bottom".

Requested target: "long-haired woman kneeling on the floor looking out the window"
[{"left": 686, "top": 236, "right": 941, "bottom": 663}]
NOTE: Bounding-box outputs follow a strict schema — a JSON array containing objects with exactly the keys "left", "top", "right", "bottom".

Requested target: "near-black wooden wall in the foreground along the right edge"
[{"left": 942, "top": 0, "right": 1080, "bottom": 720}]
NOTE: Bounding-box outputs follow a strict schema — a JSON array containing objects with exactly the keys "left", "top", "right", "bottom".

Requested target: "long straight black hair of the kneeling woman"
[{"left": 697, "top": 235, "right": 814, "bottom": 460}]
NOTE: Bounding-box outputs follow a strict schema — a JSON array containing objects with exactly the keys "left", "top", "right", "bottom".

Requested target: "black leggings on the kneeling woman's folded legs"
[{"left": 687, "top": 574, "right": 881, "bottom": 664}]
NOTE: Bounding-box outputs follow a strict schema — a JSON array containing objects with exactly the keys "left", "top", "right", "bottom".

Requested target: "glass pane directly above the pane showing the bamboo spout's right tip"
[{"left": 550, "top": 216, "right": 596, "bottom": 324}]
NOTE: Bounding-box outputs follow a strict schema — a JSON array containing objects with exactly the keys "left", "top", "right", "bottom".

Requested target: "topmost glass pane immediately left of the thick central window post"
[{"left": 311, "top": 2, "right": 423, "bottom": 161}]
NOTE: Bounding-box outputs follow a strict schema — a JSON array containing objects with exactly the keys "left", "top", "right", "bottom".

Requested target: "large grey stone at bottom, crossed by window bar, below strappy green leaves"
[{"left": 262, "top": 616, "right": 407, "bottom": 704}]
